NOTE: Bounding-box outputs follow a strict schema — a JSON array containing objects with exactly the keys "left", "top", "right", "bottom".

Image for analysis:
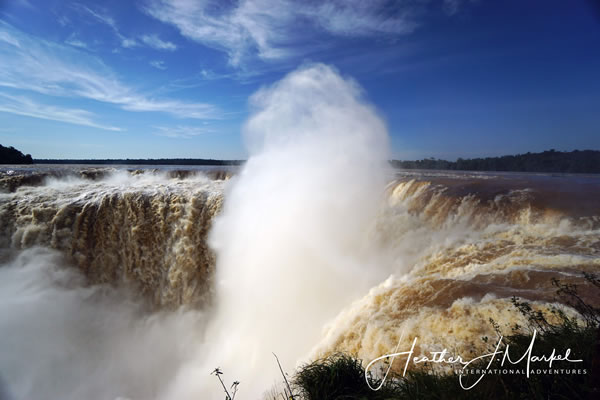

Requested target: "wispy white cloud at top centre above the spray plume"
[{"left": 143, "top": 0, "right": 446, "bottom": 65}]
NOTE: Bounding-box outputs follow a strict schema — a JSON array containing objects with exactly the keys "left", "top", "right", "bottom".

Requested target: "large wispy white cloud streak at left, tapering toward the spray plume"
[{"left": 0, "top": 21, "right": 222, "bottom": 119}]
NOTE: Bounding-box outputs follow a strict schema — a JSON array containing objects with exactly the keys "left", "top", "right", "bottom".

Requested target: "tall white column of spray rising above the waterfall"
[{"left": 164, "top": 65, "right": 387, "bottom": 398}]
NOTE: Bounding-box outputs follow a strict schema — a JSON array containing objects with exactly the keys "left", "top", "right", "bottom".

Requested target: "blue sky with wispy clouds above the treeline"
[{"left": 0, "top": 0, "right": 600, "bottom": 160}]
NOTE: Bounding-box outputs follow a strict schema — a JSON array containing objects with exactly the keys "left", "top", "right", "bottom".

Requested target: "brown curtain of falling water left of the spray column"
[{"left": 0, "top": 170, "right": 223, "bottom": 306}]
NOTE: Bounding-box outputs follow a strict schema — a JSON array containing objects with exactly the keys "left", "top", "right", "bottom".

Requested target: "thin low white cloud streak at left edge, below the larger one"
[{"left": 0, "top": 93, "right": 122, "bottom": 131}]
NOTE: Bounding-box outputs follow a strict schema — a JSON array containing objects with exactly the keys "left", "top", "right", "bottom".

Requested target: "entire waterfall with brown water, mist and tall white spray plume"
[{"left": 0, "top": 65, "right": 600, "bottom": 399}]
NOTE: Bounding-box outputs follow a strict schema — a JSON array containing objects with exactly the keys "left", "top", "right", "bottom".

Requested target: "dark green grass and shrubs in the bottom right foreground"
[{"left": 280, "top": 274, "right": 600, "bottom": 400}]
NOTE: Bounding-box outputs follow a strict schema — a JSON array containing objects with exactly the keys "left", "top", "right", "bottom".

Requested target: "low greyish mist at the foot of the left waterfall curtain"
[{"left": 0, "top": 248, "right": 205, "bottom": 400}]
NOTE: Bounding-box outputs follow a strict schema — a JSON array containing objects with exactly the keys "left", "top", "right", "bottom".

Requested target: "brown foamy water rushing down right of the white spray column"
[{"left": 313, "top": 173, "right": 600, "bottom": 366}]
